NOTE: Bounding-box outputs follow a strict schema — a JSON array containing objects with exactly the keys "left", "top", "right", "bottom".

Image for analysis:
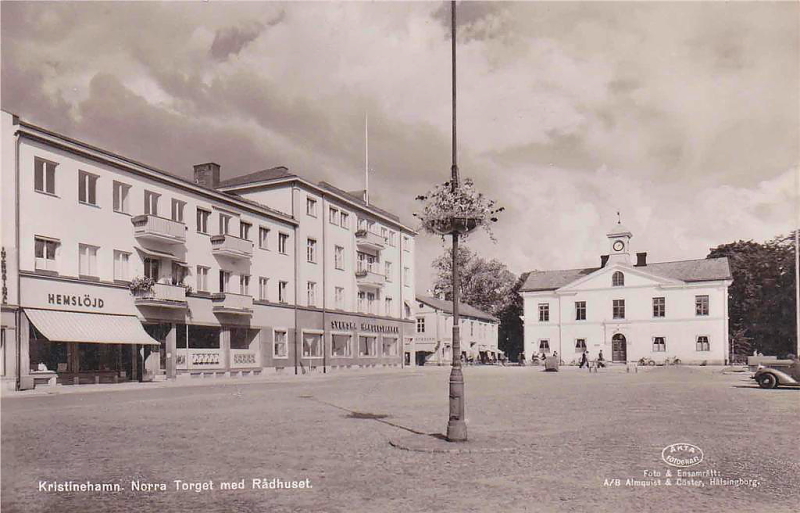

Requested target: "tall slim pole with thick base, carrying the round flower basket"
[{"left": 447, "top": 0, "right": 467, "bottom": 442}]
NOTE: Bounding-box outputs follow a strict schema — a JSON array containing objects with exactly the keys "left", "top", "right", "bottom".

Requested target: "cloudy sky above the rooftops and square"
[{"left": 1, "top": 1, "right": 800, "bottom": 290}]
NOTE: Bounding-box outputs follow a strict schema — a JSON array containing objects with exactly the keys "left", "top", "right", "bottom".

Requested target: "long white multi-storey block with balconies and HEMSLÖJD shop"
[{"left": 0, "top": 112, "right": 414, "bottom": 388}]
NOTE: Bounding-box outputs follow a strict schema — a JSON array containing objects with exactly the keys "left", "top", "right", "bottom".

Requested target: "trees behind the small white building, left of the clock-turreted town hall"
[{"left": 433, "top": 246, "right": 526, "bottom": 358}]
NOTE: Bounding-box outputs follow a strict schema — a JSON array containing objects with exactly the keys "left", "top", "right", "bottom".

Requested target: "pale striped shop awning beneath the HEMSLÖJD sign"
[{"left": 25, "top": 308, "right": 161, "bottom": 346}]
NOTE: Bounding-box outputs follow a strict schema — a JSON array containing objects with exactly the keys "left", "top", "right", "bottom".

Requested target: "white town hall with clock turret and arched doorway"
[{"left": 520, "top": 223, "right": 733, "bottom": 365}]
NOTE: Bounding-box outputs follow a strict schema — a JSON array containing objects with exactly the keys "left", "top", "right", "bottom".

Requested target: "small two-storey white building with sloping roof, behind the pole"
[{"left": 414, "top": 296, "right": 501, "bottom": 365}]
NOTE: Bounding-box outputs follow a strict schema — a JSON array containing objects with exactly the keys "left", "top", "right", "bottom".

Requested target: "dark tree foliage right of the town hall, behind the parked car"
[{"left": 708, "top": 233, "right": 797, "bottom": 356}]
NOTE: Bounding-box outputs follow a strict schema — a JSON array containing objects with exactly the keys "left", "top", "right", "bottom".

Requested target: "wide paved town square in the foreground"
[{"left": 2, "top": 366, "right": 800, "bottom": 512}]
